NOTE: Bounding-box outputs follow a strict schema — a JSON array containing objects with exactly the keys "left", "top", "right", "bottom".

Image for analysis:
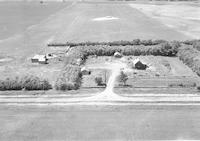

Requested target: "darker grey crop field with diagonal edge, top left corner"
[{"left": 0, "top": 1, "right": 70, "bottom": 40}]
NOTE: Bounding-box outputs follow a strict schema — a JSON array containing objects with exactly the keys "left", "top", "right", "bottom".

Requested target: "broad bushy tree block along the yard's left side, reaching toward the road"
[{"left": 55, "top": 65, "right": 82, "bottom": 90}]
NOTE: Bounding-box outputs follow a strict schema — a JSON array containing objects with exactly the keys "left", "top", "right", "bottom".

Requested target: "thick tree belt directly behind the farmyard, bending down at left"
[{"left": 65, "top": 42, "right": 180, "bottom": 65}]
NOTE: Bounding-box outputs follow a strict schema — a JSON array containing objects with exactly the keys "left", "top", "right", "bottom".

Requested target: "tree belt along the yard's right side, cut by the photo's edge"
[{"left": 177, "top": 45, "right": 200, "bottom": 76}]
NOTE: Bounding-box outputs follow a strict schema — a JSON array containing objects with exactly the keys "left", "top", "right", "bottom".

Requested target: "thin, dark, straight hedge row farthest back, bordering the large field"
[{"left": 48, "top": 39, "right": 167, "bottom": 47}]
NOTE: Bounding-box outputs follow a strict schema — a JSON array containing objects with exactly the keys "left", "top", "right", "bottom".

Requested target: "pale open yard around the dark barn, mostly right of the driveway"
[{"left": 86, "top": 56, "right": 200, "bottom": 95}]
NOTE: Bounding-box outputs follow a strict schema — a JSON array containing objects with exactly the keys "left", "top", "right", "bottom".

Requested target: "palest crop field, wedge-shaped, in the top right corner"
[{"left": 130, "top": 2, "right": 200, "bottom": 38}]
